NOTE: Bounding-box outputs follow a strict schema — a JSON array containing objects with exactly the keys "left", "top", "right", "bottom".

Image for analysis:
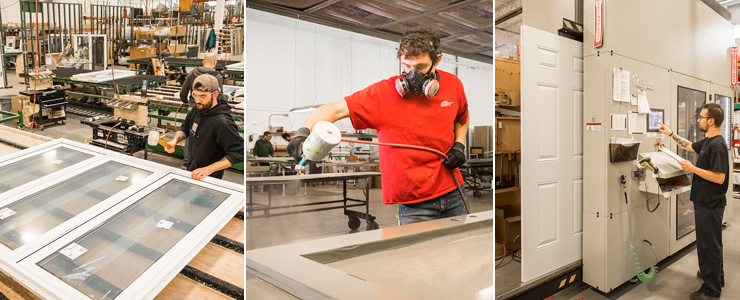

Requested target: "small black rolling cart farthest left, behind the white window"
[{"left": 20, "top": 88, "right": 67, "bottom": 130}]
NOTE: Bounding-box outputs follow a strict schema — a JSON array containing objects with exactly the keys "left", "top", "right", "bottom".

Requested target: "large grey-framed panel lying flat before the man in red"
[{"left": 244, "top": 211, "right": 494, "bottom": 300}]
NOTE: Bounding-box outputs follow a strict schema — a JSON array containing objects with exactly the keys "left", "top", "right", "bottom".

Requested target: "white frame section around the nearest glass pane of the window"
[{"left": 14, "top": 173, "right": 244, "bottom": 300}]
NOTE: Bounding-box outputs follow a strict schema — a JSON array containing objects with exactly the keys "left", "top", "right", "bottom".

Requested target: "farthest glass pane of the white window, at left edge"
[{"left": 0, "top": 146, "right": 93, "bottom": 193}]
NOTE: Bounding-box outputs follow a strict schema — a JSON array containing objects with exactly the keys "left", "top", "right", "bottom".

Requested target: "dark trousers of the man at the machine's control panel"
[{"left": 694, "top": 202, "right": 725, "bottom": 297}]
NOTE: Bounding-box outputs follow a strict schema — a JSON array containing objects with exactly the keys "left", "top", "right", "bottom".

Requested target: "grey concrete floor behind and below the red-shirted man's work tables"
[{"left": 244, "top": 184, "right": 493, "bottom": 300}]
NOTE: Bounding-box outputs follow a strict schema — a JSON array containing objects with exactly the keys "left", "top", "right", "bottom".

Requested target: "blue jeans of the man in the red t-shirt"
[{"left": 398, "top": 186, "right": 469, "bottom": 225}]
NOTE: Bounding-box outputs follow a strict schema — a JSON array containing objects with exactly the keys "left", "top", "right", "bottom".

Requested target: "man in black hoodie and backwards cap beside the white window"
[{"left": 167, "top": 74, "right": 244, "bottom": 180}]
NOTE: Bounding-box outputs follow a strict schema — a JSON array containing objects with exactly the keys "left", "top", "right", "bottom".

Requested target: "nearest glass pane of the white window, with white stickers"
[{"left": 38, "top": 180, "right": 229, "bottom": 299}]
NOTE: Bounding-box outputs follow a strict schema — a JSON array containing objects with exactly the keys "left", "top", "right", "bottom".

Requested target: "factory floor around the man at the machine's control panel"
[{"left": 495, "top": 199, "right": 740, "bottom": 300}]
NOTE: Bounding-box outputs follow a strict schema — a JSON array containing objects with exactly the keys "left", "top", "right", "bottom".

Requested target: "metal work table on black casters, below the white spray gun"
[{"left": 245, "top": 172, "right": 380, "bottom": 230}]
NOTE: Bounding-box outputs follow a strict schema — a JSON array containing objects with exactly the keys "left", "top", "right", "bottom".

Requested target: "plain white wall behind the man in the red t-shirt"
[{"left": 245, "top": 9, "right": 493, "bottom": 142}]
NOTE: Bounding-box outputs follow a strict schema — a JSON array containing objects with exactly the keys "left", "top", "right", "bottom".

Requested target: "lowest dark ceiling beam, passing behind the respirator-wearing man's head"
[{"left": 246, "top": 2, "right": 493, "bottom": 64}]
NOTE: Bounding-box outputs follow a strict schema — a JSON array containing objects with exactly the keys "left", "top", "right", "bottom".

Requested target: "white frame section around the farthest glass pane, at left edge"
[{"left": 0, "top": 139, "right": 105, "bottom": 199}]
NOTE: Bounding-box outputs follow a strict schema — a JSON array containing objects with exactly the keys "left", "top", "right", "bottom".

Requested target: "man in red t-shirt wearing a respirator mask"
[{"left": 287, "top": 29, "right": 469, "bottom": 225}]
